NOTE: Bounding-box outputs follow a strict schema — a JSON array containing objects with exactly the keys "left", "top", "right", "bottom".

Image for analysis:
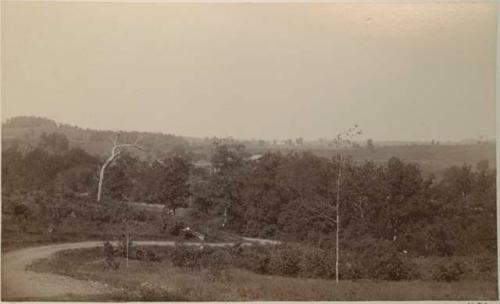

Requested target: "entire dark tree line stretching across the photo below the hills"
[{"left": 2, "top": 134, "right": 496, "bottom": 256}]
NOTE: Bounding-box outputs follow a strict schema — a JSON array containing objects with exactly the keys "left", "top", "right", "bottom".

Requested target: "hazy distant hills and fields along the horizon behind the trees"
[{"left": 2, "top": 116, "right": 496, "bottom": 176}]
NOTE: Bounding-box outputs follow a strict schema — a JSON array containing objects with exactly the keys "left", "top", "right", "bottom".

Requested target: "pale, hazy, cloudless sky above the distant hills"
[{"left": 2, "top": 1, "right": 497, "bottom": 140}]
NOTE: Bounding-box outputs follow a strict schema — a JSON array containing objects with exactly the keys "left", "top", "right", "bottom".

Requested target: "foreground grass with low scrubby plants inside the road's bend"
[{"left": 30, "top": 245, "right": 497, "bottom": 301}]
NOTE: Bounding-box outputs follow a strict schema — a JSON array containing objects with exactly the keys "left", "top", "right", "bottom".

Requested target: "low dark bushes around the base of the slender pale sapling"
[{"left": 231, "top": 242, "right": 420, "bottom": 281}]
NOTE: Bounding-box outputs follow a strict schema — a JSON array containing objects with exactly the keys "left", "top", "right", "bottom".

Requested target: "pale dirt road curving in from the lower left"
[{"left": 1, "top": 238, "right": 279, "bottom": 301}]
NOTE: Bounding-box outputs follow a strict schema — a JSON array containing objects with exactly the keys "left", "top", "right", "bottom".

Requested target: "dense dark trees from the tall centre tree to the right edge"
[{"left": 193, "top": 144, "right": 496, "bottom": 256}]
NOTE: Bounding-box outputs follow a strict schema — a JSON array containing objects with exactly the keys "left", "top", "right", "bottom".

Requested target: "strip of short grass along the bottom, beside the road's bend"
[{"left": 26, "top": 248, "right": 498, "bottom": 301}]
